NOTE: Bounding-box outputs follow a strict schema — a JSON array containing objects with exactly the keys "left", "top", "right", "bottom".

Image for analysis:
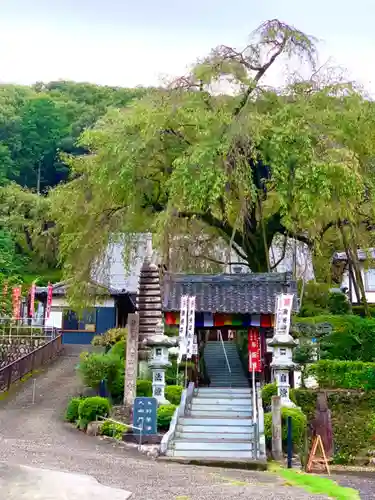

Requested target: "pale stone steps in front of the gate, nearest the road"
[{"left": 166, "top": 387, "right": 256, "bottom": 461}]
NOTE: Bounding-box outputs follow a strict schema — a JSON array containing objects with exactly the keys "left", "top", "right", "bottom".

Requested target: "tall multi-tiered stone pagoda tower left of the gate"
[{"left": 137, "top": 236, "right": 163, "bottom": 378}]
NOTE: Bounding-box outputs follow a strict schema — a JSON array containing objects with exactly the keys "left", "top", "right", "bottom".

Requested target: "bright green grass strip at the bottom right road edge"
[{"left": 273, "top": 466, "right": 360, "bottom": 500}]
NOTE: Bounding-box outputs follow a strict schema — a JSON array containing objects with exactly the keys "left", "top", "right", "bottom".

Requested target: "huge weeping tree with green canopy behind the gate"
[{"left": 52, "top": 20, "right": 375, "bottom": 296}]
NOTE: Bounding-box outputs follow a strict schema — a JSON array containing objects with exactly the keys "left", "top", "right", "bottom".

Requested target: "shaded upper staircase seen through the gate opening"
[{"left": 204, "top": 341, "right": 249, "bottom": 387}]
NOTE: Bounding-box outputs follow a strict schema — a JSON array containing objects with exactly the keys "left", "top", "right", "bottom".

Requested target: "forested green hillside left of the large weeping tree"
[{"left": 0, "top": 81, "right": 150, "bottom": 282}]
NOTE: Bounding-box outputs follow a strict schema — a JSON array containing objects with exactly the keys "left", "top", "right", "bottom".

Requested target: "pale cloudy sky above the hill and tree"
[{"left": 0, "top": 0, "right": 375, "bottom": 95}]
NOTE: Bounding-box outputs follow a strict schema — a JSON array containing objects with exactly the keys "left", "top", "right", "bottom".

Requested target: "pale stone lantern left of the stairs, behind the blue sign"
[{"left": 143, "top": 324, "right": 178, "bottom": 405}]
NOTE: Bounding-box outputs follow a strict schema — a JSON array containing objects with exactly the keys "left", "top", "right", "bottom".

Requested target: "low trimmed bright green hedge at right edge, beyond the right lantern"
[{"left": 308, "top": 360, "right": 375, "bottom": 390}]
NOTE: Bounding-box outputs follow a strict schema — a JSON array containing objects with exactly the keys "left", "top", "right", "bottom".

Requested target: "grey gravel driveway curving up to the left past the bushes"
[{"left": 0, "top": 349, "right": 328, "bottom": 500}]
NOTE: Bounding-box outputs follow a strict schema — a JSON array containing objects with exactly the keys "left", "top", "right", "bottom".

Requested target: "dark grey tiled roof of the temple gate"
[{"left": 163, "top": 273, "right": 297, "bottom": 314}]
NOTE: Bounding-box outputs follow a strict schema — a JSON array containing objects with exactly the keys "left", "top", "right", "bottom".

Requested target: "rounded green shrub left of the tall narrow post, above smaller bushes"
[{"left": 78, "top": 353, "right": 124, "bottom": 396}]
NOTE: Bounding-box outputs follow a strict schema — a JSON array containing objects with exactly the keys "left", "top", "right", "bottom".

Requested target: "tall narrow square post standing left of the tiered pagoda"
[{"left": 124, "top": 314, "right": 139, "bottom": 422}]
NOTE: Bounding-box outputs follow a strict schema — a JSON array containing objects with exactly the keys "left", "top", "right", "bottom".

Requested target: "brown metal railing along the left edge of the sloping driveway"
[{"left": 0, "top": 335, "right": 62, "bottom": 393}]
